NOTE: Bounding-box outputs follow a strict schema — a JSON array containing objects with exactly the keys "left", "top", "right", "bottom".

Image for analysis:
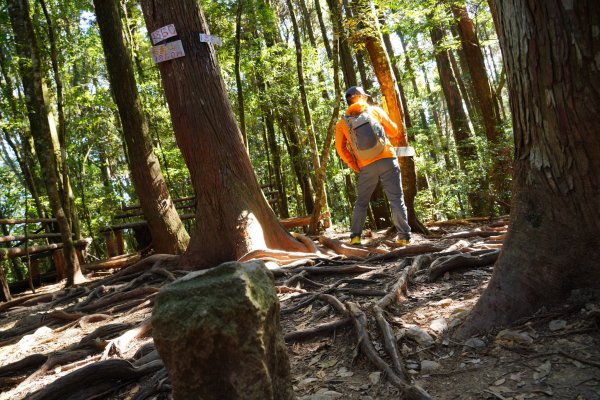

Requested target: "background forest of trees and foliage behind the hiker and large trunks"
[{"left": 0, "top": 0, "right": 512, "bottom": 288}]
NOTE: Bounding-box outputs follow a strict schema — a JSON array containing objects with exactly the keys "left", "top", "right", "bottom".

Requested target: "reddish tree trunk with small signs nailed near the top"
[{"left": 141, "top": 0, "right": 305, "bottom": 269}]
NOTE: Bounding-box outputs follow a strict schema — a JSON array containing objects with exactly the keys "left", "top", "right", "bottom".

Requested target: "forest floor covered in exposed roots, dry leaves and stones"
[{"left": 0, "top": 221, "right": 600, "bottom": 400}]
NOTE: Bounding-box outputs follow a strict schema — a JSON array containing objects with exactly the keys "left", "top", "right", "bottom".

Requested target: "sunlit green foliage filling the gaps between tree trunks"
[{"left": 0, "top": 0, "right": 512, "bottom": 282}]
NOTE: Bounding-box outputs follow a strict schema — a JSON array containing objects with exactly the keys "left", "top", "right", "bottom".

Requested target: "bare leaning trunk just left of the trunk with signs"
[{"left": 94, "top": 0, "right": 190, "bottom": 254}]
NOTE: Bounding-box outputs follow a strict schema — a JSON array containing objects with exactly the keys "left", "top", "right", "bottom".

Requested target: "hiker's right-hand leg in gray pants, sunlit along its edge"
[{"left": 380, "top": 158, "right": 410, "bottom": 240}]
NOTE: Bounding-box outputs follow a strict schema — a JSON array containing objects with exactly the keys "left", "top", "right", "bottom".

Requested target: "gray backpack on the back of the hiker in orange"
[{"left": 345, "top": 108, "right": 387, "bottom": 160}]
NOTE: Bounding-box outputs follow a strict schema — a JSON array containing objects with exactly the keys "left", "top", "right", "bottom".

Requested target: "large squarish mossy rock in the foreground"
[{"left": 152, "top": 261, "right": 294, "bottom": 400}]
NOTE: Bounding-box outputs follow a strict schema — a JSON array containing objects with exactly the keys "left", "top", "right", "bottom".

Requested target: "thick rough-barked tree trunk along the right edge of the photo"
[{"left": 458, "top": 0, "right": 600, "bottom": 337}]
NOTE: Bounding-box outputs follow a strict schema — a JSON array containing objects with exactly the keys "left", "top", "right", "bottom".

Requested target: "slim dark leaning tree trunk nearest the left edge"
[{"left": 8, "top": 0, "right": 85, "bottom": 286}]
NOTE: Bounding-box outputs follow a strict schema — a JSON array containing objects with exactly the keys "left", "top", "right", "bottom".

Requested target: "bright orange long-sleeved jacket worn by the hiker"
[{"left": 335, "top": 101, "right": 398, "bottom": 172}]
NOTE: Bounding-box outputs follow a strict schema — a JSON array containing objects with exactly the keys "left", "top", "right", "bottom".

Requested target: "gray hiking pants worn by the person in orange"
[{"left": 350, "top": 158, "right": 410, "bottom": 237}]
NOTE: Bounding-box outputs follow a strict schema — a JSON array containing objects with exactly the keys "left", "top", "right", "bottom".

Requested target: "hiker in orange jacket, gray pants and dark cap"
[{"left": 335, "top": 86, "right": 410, "bottom": 245}]
